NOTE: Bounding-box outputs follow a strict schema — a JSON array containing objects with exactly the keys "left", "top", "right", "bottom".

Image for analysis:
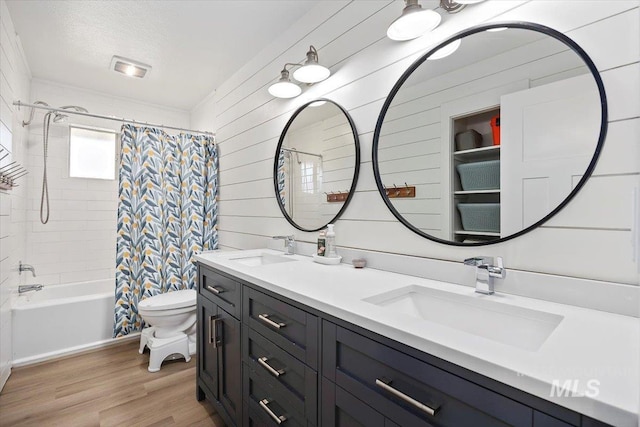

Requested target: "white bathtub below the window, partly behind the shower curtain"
[{"left": 12, "top": 279, "right": 132, "bottom": 366}]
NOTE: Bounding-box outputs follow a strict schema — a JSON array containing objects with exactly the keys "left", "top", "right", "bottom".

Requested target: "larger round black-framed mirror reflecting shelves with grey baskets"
[{"left": 373, "top": 22, "right": 607, "bottom": 246}]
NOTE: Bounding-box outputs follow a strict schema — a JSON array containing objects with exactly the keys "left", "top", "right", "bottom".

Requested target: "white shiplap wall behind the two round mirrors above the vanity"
[{"left": 191, "top": 0, "right": 640, "bottom": 285}]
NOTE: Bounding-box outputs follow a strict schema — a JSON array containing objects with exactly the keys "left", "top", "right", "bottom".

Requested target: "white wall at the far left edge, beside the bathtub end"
[{"left": 0, "top": 1, "right": 31, "bottom": 390}]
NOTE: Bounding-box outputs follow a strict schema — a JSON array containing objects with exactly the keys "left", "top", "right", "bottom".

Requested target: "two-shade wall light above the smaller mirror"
[{"left": 268, "top": 46, "right": 331, "bottom": 98}]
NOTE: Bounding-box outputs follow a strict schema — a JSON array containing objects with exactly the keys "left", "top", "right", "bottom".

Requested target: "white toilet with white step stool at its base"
[{"left": 138, "top": 289, "right": 197, "bottom": 372}]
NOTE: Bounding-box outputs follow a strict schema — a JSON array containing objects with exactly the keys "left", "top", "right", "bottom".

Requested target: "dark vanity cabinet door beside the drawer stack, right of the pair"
[{"left": 216, "top": 308, "right": 242, "bottom": 425}]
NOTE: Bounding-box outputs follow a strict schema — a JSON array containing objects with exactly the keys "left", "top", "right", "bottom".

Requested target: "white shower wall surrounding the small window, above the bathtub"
[{"left": 25, "top": 77, "right": 189, "bottom": 285}]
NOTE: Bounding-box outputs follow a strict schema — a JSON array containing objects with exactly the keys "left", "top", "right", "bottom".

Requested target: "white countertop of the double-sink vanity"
[{"left": 196, "top": 249, "right": 640, "bottom": 427}]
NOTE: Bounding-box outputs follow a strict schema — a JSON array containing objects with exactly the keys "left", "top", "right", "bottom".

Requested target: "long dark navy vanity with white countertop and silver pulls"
[{"left": 197, "top": 249, "right": 640, "bottom": 427}]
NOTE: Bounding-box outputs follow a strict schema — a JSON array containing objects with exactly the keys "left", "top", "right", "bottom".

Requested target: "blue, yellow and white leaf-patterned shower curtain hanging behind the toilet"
[{"left": 113, "top": 125, "right": 218, "bottom": 337}]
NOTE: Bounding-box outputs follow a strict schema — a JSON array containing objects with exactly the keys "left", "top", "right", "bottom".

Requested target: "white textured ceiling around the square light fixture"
[{"left": 7, "top": 0, "right": 319, "bottom": 110}]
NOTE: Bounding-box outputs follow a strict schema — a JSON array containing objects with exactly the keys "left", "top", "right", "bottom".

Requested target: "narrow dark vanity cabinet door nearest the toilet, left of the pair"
[{"left": 197, "top": 298, "right": 218, "bottom": 400}]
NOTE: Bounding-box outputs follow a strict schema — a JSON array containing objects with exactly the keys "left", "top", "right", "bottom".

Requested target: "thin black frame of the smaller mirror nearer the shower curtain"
[{"left": 273, "top": 98, "right": 360, "bottom": 232}]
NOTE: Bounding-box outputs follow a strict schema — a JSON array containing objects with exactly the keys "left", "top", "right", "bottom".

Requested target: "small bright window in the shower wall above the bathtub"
[{"left": 69, "top": 126, "right": 118, "bottom": 179}]
